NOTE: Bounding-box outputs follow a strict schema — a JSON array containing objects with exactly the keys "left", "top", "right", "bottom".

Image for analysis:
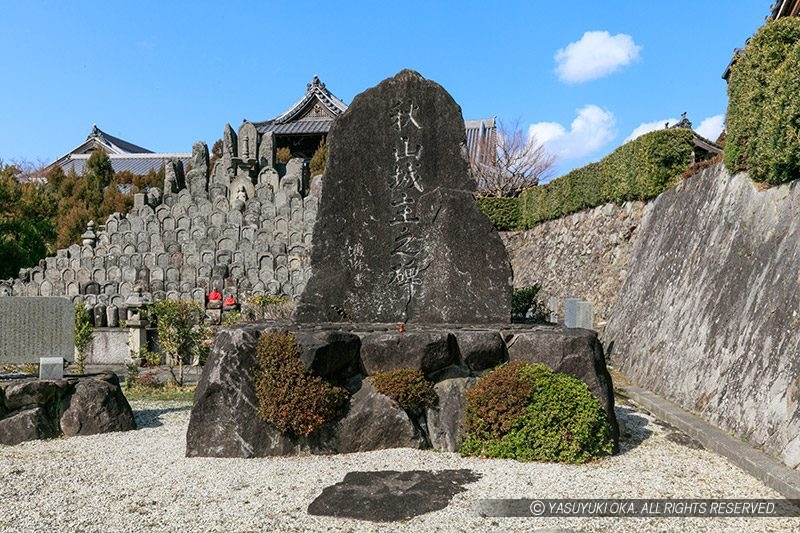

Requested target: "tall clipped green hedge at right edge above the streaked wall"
[{"left": 725, "top": 17, "right": 800, "bottom": 185}]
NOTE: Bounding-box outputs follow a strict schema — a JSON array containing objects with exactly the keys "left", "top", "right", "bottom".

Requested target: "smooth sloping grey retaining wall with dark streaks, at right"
[{"left": 604, "top": 165, "right": 800, "bottom": 468}]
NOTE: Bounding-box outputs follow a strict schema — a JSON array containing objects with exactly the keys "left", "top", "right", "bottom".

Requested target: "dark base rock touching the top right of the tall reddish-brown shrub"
[{"left": 295, "top": 331, "right": 361, "bottom": 379}]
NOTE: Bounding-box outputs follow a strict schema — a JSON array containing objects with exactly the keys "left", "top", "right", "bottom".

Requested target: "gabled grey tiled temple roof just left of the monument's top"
[{"left": 253, "top": 76, "right": 347, "bottom": 135}]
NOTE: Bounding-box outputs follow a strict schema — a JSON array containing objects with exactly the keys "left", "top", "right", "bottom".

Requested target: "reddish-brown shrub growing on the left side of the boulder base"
[{"left": 255, "top": 332, "right": 349, "bottom": 437}]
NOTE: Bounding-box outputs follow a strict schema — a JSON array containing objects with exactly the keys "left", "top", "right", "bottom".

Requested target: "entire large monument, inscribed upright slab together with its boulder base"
[{"left": 186, "top": 70, "right": 618, "bottom": 457}]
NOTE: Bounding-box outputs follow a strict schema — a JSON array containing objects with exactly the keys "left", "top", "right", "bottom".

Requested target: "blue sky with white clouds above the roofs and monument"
[{"left": 0, "top": 0, "right": 771, "bottom": 178}]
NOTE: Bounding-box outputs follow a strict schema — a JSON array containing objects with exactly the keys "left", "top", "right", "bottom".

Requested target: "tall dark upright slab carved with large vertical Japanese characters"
[{"left": 295, "top": 70, "right": 511, "bottom": 324}]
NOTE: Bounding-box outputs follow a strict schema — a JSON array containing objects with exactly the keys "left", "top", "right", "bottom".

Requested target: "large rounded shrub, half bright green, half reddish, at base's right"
[{"left": 461, "top": 361, "right": 613, "bottom": 463}]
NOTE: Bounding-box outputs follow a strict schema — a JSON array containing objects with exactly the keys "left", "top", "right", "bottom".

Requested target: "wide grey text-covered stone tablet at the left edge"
[{"left": 0, "top": 296, "right": 75, "bottom": 364}]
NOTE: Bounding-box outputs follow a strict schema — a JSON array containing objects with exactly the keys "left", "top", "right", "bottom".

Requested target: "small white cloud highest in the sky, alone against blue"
[{"left": 555, "top": 31, "right": 642, "bottom": 83}]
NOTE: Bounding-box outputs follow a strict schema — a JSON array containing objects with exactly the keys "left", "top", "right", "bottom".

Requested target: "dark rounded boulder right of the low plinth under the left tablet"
[{"left": 60, "top": 379, "right": 136, "bottom": 437}]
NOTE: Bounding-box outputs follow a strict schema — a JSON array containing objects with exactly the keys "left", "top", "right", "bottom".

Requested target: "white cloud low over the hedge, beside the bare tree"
[{"left": 528, "top": 105, "right": 617, "bottom": 160}]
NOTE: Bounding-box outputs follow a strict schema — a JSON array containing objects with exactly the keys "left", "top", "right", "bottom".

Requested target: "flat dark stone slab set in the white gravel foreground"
[{"left": 308, "top": 470, "right": 481, "bottom": 522}]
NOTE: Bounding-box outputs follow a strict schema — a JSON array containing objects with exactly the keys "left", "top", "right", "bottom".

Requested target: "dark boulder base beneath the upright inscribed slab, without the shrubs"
[{"left": 186, "top": 322, "right": 619, "bottom": 457}]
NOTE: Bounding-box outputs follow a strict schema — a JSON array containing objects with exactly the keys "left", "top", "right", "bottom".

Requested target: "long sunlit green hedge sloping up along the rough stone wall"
[{"left": 518, "top": 128, "right": 694, "bottom": 229}]
